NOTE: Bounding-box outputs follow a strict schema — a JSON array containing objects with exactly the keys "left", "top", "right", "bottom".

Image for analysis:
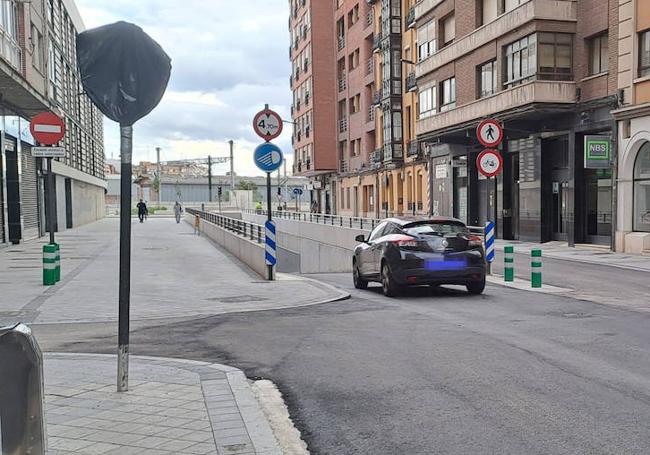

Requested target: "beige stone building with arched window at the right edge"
[{"left": 613, "top": 0, "right": 650, "bottom": 254}]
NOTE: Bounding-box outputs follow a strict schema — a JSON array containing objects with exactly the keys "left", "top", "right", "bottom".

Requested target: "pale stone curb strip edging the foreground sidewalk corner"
[{"left": 44, "top": 352, "right": 282, "bottom": 455}]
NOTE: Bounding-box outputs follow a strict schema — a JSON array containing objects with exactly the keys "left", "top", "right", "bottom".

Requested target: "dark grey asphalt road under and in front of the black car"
[{"left": 35, "top": 264, "right": 650, "bottom": 455}]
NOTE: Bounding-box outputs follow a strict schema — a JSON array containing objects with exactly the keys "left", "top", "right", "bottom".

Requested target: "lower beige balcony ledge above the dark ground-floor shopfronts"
[{"left": 417, "top": 81, "right": 576, "bottom": 135}]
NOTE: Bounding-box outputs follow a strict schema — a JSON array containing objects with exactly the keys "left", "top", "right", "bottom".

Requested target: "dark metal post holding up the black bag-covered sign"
[{"left": 117, "top": 125, "right": 133, "bottom": 392}]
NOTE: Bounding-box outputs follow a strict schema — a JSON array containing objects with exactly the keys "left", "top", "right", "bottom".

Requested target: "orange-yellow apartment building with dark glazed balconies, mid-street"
[{"left": 337, "top": 0, "right": 428, "bottom": 217}]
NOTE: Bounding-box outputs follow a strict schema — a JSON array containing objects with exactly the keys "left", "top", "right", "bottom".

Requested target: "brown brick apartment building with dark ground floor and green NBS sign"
[{"left": 415, "top": 0, "right": 616, "bottom": 245}]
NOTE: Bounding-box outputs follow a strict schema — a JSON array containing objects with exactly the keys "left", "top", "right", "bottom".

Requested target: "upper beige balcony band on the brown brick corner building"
[{"left": 416, "top": 0, "right": 577, "bottom": 77}]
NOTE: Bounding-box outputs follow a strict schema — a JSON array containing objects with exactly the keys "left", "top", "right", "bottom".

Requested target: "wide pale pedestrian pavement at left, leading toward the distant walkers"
[{"left": 0, "top": 218, "right": 349, "bottom": 325}]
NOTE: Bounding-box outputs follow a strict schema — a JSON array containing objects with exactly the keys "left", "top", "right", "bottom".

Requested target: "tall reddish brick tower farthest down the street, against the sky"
[{"left": 289, "top": 0, "right": 339, "bottom": 212}]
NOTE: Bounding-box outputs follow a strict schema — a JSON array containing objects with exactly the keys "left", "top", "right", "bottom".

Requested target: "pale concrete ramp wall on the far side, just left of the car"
[{"left": 243, "top": 213, "right": 369, "bottom": 273}]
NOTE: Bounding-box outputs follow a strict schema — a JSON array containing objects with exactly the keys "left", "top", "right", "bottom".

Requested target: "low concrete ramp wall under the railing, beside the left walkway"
[{"left": 185, "top": 213, "right": 301, "bottom": 279}]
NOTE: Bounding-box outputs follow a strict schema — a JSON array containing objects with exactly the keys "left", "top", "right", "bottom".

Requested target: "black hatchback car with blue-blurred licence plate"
[{"left": 352, "top": 217, "right": 487, "bottom": 297}]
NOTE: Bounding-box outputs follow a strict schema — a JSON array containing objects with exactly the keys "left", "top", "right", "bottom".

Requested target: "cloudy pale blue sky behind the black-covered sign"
[{"left": 77, "top": 0, "right": 293, "bottom": 175}]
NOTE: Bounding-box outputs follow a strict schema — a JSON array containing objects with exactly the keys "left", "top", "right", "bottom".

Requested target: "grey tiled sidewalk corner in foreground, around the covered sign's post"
[{"left": 44, "top": 354, "right": 282, "bottom": 455}]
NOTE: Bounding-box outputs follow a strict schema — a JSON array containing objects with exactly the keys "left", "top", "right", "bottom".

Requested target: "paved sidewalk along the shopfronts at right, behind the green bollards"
[{"left": 494, "top": 240, "right": 650, "bottom": 272}]
